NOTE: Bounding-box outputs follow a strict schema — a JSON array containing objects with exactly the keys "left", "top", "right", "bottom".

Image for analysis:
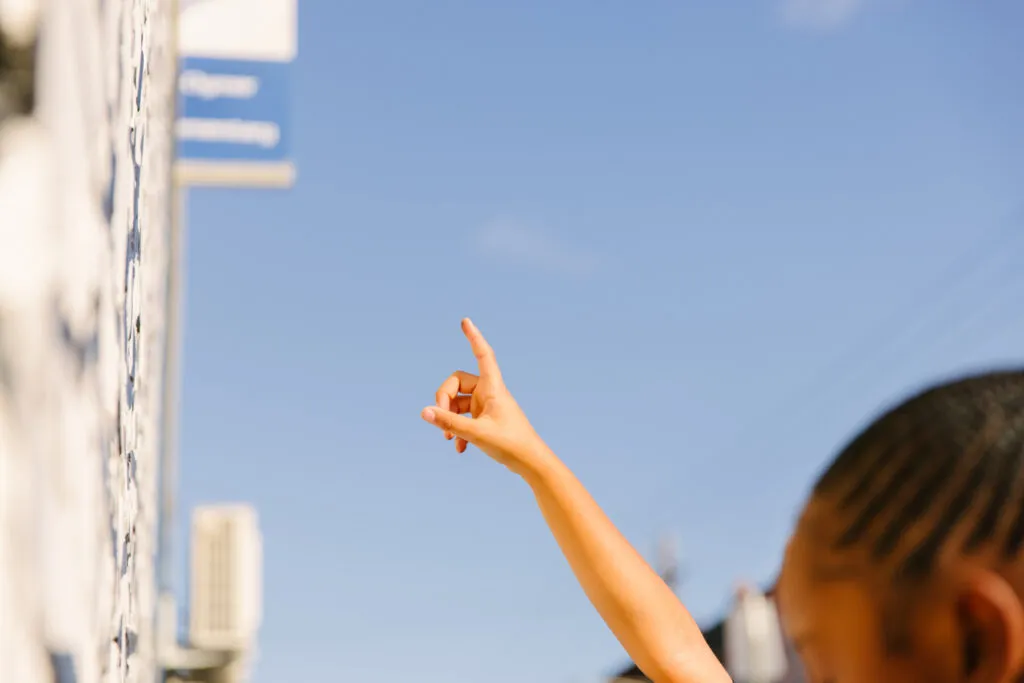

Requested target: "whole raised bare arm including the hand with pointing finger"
[{"left": 423, "top": 319, "right": 729, "bottom": 683}]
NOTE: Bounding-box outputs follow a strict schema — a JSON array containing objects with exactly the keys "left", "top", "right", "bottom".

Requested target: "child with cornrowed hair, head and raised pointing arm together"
[{"left": 422, "top": 319, "right": 1024, "bottom": 683}]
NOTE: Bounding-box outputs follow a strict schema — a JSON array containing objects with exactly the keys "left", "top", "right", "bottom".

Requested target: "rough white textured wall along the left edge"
[{"left": 0, "top": 0, "right": 174, "bottom": 683}]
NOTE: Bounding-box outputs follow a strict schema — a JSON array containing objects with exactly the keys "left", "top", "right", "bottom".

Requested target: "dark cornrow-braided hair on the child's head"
[{"left": 814, "top": 371, "right": 1024, "bottom": 579}]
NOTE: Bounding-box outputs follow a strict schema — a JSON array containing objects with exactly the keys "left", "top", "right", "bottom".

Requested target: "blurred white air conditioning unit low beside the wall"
[{"left": 188, "top": 505, "right": 263, "bottom": 651}]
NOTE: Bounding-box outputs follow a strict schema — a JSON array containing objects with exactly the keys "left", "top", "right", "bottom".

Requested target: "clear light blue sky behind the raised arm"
[{"left": 174, "top": 0, "right": 1024, "bottom": 683}]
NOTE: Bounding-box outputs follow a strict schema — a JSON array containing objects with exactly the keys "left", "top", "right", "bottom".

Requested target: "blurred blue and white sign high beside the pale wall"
[{"left": 175, "top": 0, "right": 297, "bottom": 186}]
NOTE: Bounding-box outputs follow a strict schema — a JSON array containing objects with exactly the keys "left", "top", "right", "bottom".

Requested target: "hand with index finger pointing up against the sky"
[{"left": 422, "top": 317, "right": 545, "bottom": 475}]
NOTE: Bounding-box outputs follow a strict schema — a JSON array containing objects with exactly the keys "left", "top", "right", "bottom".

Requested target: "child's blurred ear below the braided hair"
[{"left": 956, "top": 571, "right": 1024, "bottom": 683}]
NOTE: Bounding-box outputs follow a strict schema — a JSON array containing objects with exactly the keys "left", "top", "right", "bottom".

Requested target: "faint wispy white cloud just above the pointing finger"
[{"left": 475, "top": 220, "right": 601, "bottom": 278}]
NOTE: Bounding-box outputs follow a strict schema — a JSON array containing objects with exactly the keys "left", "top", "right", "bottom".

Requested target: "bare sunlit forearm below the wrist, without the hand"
[{"left": 524, "top": 446, "right": 729, "bottom": 683}]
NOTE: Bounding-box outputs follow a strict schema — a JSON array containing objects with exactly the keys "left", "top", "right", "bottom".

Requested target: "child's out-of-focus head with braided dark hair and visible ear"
[{"left": 778, "top": 372, "right": 1024, "bottom": 683}]
